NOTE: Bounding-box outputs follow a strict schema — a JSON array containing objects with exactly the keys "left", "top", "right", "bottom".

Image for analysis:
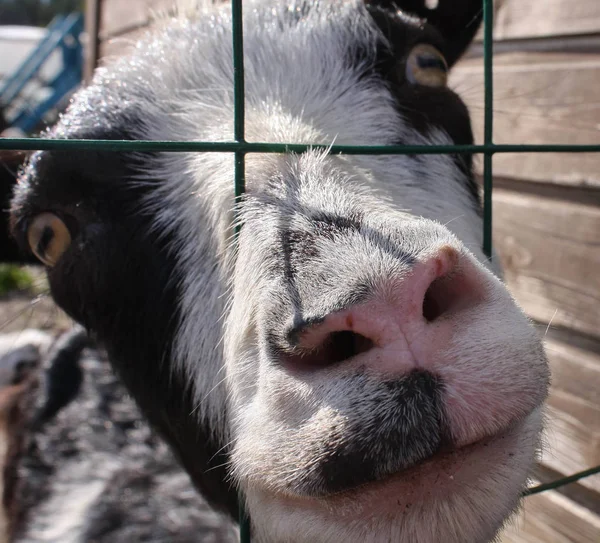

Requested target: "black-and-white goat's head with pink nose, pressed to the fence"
[{"left": 12, "top": 0, "right": 548, "bottom": 543}]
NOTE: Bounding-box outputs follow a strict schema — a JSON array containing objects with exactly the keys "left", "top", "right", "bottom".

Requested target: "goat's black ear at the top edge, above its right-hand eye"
[{"left": 366, "top": 0, "right": 483, "bottom": 66}]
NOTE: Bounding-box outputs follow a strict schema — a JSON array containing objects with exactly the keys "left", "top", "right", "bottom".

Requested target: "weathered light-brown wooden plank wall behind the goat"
[{"left": 97, "top": 0, "right": 600, "bottom": 543}]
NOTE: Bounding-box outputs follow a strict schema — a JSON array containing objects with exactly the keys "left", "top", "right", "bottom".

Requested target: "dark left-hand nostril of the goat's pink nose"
[{"left": 283, "top": 330, "right": 374, "bottom": 369}]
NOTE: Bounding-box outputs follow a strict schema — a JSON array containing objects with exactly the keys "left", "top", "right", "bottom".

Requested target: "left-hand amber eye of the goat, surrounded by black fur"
[{"left": 27, "top": 213, "right": 71, "bottom": 268}]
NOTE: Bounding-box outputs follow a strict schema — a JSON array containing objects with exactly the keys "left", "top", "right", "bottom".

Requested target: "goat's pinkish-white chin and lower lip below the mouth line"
[{"left": 247, "top": 408, "right": 542, "bottom": 543}]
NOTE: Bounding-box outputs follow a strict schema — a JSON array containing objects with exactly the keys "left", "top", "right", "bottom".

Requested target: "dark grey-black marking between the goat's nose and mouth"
[{"left": 305, "top": 370, "right": 445, "bottom": 496}]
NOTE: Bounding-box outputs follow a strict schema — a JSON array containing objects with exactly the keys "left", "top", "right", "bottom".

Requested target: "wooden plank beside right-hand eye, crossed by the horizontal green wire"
[{"left": 450, "top": 51, "right": 600, "bottom": 188}]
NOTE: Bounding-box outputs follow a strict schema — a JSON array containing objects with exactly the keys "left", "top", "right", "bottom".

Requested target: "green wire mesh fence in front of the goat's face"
[{"left": 0, "top": 0, "right": 600, "bottom": 543}]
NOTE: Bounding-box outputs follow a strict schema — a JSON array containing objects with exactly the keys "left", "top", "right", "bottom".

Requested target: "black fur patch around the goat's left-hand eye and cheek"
[{"left": 13, "top": 133, "right": 238, "bottom": 516}]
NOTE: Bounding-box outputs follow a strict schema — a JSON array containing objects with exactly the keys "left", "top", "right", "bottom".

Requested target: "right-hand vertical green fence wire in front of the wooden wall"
[{"left": 483, "top": 0, "right": 494, "bottom": 259}]
